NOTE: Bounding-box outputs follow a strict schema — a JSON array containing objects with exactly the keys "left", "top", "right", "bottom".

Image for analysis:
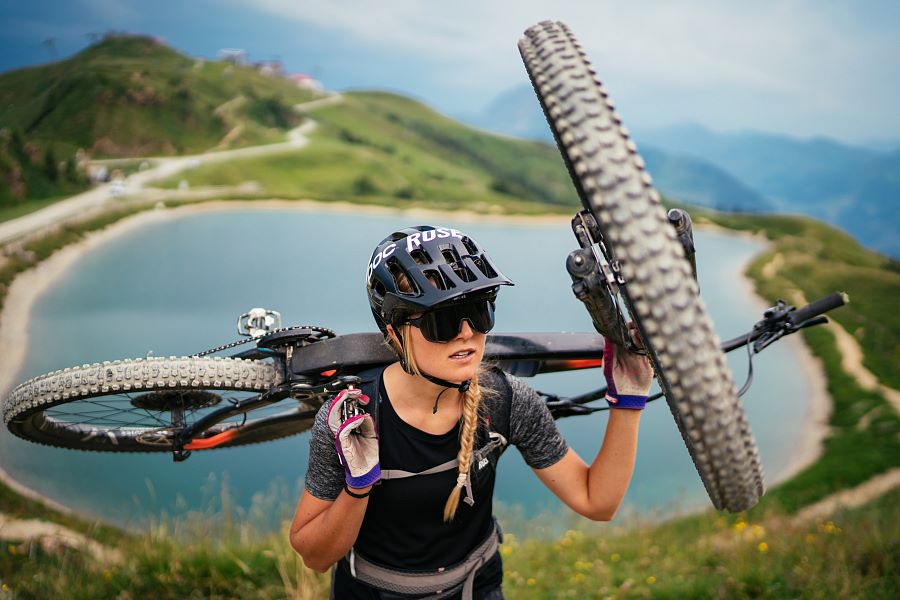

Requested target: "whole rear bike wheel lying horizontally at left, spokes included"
[{"left": 3, "top": 357, "right": 312, "bottom": 452}]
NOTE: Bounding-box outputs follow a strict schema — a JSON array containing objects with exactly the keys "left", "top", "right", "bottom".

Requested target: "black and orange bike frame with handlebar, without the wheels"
[{"left": 167, "top": 294, "right": 847, "bottom": 461}]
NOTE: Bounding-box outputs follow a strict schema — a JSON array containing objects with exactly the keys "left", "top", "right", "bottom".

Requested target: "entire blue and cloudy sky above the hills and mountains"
[{"left": 0, "top": 0, "right": 900, "bottom": 144}]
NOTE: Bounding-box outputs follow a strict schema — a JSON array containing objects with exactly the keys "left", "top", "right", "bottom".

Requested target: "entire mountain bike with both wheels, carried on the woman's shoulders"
[{"left": 2, "top": 22, "right": 846, "bottom": 512}]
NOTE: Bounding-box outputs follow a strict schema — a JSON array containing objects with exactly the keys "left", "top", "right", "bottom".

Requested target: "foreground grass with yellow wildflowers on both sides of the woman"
[{"left": 0, "top": 472, "right": 900, "bottom": 600}]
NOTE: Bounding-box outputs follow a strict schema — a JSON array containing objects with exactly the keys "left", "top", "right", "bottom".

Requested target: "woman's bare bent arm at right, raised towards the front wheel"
[{"left": 534, "top": 410, "right": 641, "bottom": 521}]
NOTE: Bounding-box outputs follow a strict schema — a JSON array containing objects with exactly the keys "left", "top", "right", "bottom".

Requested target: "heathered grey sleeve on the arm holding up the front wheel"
[{"left": 506, "top": 375, "right": 569, "bottom": 469}]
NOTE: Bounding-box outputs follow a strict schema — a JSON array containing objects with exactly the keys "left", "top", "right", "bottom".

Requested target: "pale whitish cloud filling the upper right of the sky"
[{"left": 237, "top": 0, "right": 900, "bottom": 139}]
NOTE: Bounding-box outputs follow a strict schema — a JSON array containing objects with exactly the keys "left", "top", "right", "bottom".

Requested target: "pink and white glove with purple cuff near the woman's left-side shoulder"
[{"left": 328, "top": 389, "right": 381, "bottom": 488}]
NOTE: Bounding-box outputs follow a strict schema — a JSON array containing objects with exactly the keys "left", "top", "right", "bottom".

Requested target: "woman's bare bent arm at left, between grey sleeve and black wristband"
[{"left": 290, "top": 486, "right": 371, "bottom": 573}]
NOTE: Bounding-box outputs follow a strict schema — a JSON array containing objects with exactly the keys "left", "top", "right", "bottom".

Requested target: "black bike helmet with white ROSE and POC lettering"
[{"left": 366, "top": 225, "right": 514, "bottom": 335}]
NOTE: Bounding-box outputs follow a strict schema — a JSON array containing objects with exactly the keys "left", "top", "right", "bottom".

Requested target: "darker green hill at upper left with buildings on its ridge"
[{"left": 0, "top": 36, "right": 322, "bottom": 157}]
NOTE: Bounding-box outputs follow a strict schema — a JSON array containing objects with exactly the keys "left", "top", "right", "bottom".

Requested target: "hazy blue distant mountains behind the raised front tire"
[{"left": 470, "top": 85, "right": 900, "bottom": 257}]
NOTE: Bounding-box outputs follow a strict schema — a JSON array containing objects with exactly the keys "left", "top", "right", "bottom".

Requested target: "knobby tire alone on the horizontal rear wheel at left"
[{"left": 3, "top": 357, "right": 284, "bottom": 452}]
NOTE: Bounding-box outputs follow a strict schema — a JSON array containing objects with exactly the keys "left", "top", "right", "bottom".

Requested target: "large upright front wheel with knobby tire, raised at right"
[{"left": 519, "top": 21, "right": 764, "bottom": 512}]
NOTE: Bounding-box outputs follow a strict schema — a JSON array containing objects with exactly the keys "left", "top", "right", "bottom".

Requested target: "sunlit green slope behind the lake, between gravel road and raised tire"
[{"left": 163, "top": 92, "right": 578, "bottom": 212}]
